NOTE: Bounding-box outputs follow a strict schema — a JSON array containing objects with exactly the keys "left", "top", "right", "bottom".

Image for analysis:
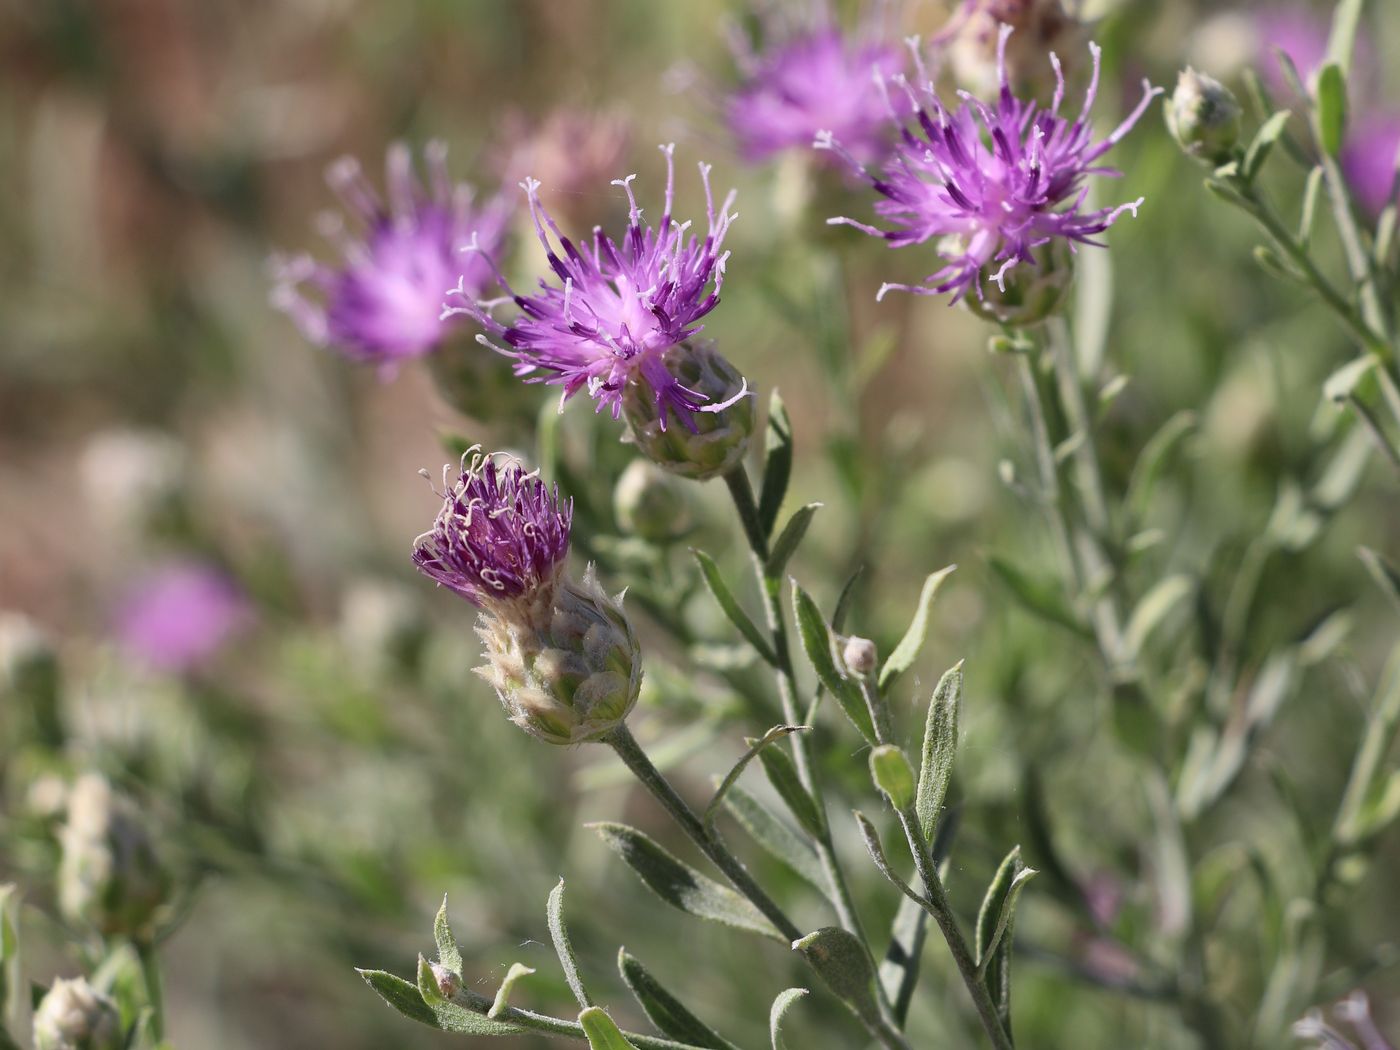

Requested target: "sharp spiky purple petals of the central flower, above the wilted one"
[{"left": 444, "top": 146, "right": 746, "bottom": 430}]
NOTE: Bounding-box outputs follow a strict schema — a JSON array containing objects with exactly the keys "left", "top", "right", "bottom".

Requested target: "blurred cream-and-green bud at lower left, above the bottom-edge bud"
[{"left": 59, "top": 773, "right": 169, "bottom": 938}]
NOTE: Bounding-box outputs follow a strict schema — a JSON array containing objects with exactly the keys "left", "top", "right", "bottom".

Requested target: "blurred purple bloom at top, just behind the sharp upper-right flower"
[{"left": 724, "top": 4, "right": 904, "bottom": 162}]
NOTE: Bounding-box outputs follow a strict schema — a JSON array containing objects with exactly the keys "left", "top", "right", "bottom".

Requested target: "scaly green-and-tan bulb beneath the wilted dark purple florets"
[{"left": 476, "top": 566, "right": 641, "bottom": 743}]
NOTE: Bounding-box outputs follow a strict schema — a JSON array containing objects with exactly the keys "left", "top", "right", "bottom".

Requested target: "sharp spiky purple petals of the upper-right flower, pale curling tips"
[{"left": 818, "top": 27, "right": 1161, "bottom": 302}]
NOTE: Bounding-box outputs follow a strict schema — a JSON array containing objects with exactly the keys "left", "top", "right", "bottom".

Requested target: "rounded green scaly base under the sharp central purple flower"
[{"left": 622, "top": 343, "right": 753, "bottom": 482}]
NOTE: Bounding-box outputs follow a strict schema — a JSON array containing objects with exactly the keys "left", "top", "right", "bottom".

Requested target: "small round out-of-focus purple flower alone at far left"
[{"left": 116, "top": 561, "right": 252, "bottom": 672}]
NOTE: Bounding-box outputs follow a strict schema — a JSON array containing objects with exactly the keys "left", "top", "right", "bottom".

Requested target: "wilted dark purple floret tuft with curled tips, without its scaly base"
[{"left": 413, "top": 448, "right": 574, "bottom": 609}]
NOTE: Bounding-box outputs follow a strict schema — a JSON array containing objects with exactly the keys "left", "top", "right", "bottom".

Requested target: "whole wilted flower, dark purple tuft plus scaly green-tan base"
[{"left": 413, "top": 449, "right": 641, "bottom": 743}]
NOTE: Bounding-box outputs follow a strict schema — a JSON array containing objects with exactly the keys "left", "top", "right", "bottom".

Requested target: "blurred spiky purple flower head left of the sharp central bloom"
[{"left": 272, "top": 141, "right": 510, "bottom": 374}]
